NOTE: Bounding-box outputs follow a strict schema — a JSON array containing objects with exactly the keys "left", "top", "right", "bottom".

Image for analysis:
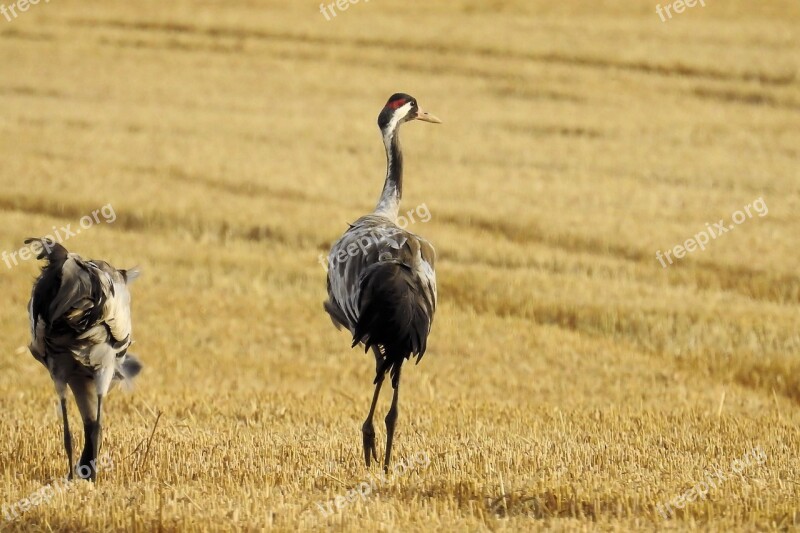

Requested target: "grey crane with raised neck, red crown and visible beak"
[{"left": 324, "top": 93, "right": 441, "bottom": 471}]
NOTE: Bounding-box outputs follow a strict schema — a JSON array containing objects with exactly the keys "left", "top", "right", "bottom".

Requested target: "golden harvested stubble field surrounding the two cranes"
[{"left": 0, "top": 0, "right": 800, "bottom": 531}]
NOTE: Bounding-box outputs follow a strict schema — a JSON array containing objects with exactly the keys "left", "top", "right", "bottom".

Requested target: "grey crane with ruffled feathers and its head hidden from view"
[{"left": 25, "top": 239, "right": 142, "bottom": 481}]
